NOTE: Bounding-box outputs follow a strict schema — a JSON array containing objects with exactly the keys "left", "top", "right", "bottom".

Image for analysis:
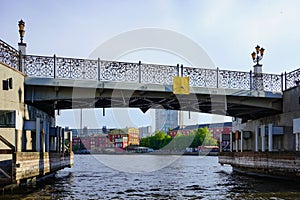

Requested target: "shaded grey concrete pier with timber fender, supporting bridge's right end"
[{"left": 219, "top": 85, "right": 300, "bottom": 180}]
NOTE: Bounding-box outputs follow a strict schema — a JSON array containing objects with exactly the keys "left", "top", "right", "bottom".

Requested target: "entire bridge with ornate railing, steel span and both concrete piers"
[{"left": 0, "top": 36, "right": 300, "bottom": 183}]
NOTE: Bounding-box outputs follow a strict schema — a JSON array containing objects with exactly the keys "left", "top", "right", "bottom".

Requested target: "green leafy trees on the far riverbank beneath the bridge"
[{"left": 141, "top": 127, "right": 217, "bottom": 150}]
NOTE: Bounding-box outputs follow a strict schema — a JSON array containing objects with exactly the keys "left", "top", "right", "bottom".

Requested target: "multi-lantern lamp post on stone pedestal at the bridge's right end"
[{"left": 251, "top": 45, "right": 265, "bottom": 90}]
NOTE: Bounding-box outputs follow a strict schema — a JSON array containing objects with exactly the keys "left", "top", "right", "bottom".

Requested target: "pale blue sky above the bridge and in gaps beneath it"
[{"left": 0, "top": 0, "right": 300, "bottom": 130}]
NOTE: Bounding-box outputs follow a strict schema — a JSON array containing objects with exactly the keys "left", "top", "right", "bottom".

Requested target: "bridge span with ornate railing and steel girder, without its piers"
[{"left": 0, "top": 40, "right": 300, "bottom": 121}]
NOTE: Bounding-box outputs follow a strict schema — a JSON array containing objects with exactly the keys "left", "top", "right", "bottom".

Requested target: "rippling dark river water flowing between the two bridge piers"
[{"left": 0, "top": 154, "right": 300, "bottom": 200}]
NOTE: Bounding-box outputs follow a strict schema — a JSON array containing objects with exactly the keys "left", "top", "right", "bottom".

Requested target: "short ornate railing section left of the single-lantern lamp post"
[{"left": 0, "top": 40, "right": 20, "bottom": 70}]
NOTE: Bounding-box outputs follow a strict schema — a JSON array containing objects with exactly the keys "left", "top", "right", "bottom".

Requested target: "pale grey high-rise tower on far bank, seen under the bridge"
[{"left": 155, "top": 109, "right": 178, "bottom": 132}]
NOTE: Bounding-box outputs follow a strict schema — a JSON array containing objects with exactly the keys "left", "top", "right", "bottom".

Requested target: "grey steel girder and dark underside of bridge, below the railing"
[{"left": 25, "top": 78, "right": 282, "bottom": 121}]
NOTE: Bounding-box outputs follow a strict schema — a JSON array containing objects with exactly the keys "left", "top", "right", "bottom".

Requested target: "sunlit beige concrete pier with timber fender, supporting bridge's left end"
[{"left": 0, "top": 62, "right": 73, "bottom": 186}]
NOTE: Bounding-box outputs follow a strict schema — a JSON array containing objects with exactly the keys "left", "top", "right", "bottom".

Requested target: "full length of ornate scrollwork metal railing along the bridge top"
[{"left": 0, "top": 40, "right": 300, "bottom": 93}]
